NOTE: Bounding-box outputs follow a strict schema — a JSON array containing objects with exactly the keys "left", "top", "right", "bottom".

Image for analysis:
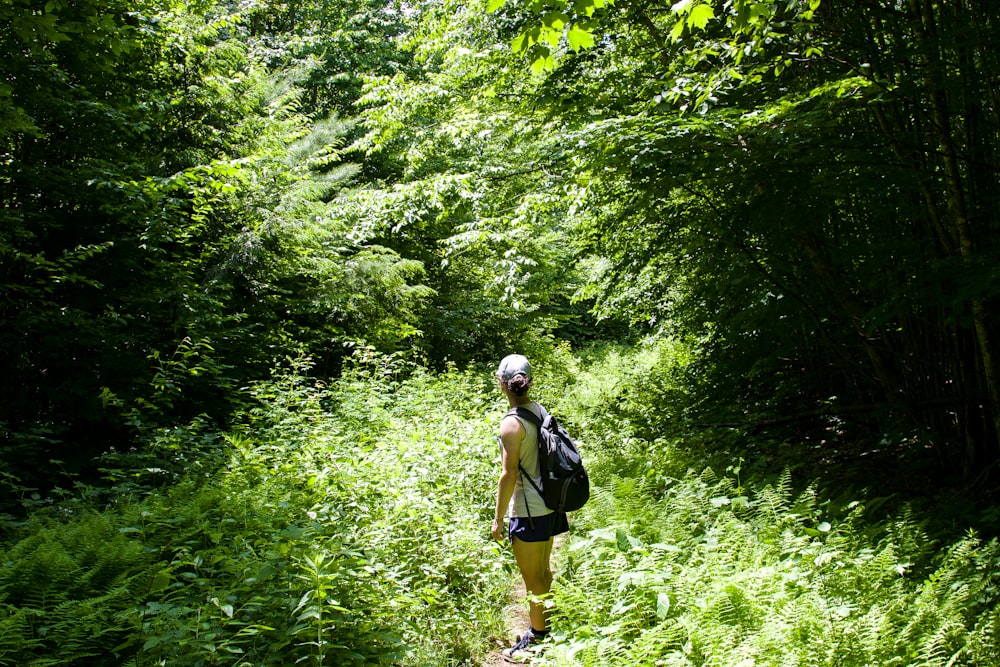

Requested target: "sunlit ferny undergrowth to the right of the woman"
[{"left": 533, "top": 342, "right": 1000, "bottom": 667}]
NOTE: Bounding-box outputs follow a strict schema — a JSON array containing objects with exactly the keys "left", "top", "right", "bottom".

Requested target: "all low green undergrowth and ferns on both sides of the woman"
[{"left": 0, "top": 342, "right": 1000, "bottom": 667}]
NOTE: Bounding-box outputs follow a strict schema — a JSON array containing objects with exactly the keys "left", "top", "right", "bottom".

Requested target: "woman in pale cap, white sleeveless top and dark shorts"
[{"left": 492, "top": 354, "right": 569, "bottom": 658}]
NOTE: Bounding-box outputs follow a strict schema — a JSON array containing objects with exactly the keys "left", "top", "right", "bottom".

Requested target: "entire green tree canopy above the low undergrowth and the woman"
[{"left": 0, "top": 0, "right": 1000, "bottom": 496}]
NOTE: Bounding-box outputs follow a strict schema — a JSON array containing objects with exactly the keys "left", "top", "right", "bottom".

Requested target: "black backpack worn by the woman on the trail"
[{"left": 507, "top": 408, "right": 590, "bottom": 512}]
